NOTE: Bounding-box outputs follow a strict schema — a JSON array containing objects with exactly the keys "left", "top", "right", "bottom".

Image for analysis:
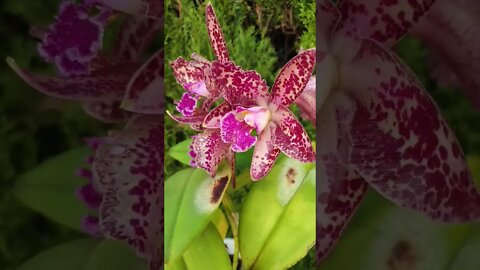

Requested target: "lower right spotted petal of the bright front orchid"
[{"left": 272, "top": 107, "right": 315, "bottom": 162}]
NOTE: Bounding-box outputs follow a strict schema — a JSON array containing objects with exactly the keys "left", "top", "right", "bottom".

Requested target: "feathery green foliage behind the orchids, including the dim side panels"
[{"left": 0, "top": 0, "right": 480, "bottom": 270}]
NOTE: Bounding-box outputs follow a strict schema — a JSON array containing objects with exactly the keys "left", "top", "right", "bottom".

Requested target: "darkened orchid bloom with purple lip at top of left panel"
[{"left": 7, "top": 1, "right": 163, "bottom": 122}]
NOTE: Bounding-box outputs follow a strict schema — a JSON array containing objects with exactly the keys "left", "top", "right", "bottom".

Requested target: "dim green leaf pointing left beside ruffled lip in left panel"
[{"left": 13, "top": 148, "right": 91, "bottom": 231}]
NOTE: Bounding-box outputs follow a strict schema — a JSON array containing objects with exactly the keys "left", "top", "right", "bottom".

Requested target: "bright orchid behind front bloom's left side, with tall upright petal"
[{"left": 170, "top": 3, "right": 229, "bottom": 125}]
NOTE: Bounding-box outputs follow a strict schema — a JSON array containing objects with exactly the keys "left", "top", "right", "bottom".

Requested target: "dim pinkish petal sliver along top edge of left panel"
[{"left": 88, "top": 0, "right": 163, "bottom": 19}]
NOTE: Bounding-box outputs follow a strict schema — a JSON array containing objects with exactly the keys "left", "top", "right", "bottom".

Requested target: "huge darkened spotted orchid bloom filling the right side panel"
[{"left": 316, "top": 0, "right": 480, "bottom": 262}]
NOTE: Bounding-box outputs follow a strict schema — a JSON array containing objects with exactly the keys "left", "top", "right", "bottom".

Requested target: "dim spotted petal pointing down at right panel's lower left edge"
[{"left": 316, "top": 154, "right": 368, "bottom": 265}]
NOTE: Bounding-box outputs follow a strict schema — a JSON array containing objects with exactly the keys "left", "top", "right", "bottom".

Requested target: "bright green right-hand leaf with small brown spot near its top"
[{"left": 239, "top": 158, "right": 315, "bottom": 269}]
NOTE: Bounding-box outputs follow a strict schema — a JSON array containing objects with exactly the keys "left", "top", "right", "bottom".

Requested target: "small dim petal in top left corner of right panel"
[{"left": 316, "top": 0, "right": 341, "bottom": 51}]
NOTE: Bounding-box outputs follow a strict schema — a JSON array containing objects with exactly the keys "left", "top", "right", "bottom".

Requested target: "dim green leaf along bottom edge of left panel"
[{"left": 18, "top": 239, "right": 148, "bottom": 270}]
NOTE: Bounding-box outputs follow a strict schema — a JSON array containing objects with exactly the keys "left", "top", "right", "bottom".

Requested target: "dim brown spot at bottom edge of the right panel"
[{"left": 387, "top": 240, "right": 418, "bottom": 270}]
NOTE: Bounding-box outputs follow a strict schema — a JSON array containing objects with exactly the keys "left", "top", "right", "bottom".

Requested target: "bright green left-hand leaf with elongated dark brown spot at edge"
[{"left": 164, "top": 169, "right": 230, "bottom": 264}]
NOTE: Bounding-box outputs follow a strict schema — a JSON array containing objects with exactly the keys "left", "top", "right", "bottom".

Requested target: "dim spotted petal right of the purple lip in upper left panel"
[{"left": 114, "top": 16, "right": 163, "bottom": 61}]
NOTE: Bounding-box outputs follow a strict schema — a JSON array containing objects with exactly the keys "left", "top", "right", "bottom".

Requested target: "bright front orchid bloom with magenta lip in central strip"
[{"left": 204, "top": 49, "right": 315, "bottom": 180}]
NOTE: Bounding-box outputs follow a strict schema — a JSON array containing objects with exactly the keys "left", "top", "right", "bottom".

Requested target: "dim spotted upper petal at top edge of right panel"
[{"left": 338, "top": 0, "right": 436, "bottom": 45}]
